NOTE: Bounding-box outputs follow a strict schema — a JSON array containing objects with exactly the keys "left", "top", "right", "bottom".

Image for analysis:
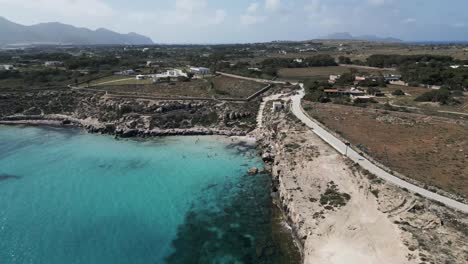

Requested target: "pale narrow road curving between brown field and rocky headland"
[{"left": 291, "top": 85, "right": 468, "bottom": 213}]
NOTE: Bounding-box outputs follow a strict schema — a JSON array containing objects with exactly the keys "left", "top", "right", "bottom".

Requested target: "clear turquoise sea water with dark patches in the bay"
[{"left": 0, "top": 126, "right": 296, "bottom": 264}]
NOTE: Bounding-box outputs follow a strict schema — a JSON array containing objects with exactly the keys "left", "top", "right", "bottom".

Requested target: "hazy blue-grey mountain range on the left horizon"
[{"left": 0, "top": 17, "right": 153, "bottom": 45}]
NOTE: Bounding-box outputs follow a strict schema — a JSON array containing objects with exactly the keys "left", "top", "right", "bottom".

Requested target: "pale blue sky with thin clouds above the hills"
[{"left": 0, "top": 0, "right": 468, "bottom": 43}]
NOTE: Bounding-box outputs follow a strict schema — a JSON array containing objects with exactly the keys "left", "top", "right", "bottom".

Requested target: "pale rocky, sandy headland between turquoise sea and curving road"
[{"left": 258, "top": 107, "right": 468, "bottom": 264}]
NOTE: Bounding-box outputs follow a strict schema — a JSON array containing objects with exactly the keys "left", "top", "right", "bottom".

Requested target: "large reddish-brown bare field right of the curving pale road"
[{"left": 304, "top": 103, "right": 468, "bottom": 197}]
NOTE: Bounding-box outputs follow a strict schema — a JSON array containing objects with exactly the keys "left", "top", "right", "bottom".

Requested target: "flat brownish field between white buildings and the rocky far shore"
[{"left": 85, "top": 76, "right": 265, "bottom": 98}]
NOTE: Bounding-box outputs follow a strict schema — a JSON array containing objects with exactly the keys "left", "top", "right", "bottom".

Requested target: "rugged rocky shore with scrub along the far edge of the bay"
[{"left": 0, "top": 90, "right": 259, "bottom": 137}]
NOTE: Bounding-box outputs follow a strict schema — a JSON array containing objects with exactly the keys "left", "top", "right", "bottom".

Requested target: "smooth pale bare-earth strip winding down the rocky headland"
[{"left": 304, "top": 148, "right": 412, "bottom": 264}]
